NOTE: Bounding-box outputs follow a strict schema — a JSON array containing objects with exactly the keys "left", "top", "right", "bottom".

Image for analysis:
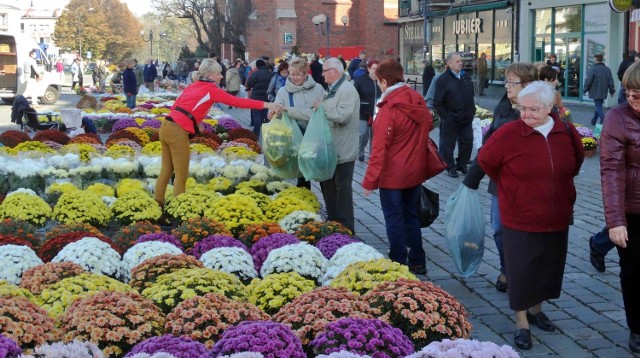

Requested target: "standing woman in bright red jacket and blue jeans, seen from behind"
[{"left": 362, "top": 60, "right": 433, "bottom": 274}]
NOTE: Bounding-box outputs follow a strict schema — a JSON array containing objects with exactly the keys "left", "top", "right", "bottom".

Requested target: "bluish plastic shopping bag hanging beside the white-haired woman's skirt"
[{"left": 444, "top": 184, "right": 485, "bottom": 277}]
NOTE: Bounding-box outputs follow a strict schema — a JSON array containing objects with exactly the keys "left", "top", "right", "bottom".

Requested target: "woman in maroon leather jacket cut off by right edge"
[{"left": 600, "top": 62, "right": 640, "bottom": 353}]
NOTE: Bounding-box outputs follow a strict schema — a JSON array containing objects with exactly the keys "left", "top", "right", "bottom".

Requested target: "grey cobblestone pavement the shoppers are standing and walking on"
[{"left": 0, "top": 87, "right": 639, "bottom": 358}]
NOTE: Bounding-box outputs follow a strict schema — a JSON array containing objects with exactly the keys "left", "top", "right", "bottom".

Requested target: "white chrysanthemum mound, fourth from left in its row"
[{"left": 200, "top": 247, "right": 258, "bottom": 280}]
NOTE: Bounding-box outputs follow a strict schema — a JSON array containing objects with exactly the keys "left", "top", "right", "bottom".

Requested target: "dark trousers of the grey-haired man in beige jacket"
[{"left": 320, "top": 162, "right": 355, "bottom": 234}]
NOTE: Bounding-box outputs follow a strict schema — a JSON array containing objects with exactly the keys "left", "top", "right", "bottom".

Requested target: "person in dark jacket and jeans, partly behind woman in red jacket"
[{"left": 353, "top": 60, "right": 380, "bottom": 162}]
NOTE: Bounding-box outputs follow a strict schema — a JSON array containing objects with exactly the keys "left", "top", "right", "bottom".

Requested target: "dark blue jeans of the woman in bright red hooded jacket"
[{"left": 380, "top": 185, "right": 426, "bottom": 266}]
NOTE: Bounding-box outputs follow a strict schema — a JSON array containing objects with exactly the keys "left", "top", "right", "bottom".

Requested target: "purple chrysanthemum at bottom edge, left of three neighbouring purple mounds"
[{"left": 125, "top": 334, "right": 211, "bottom": 358}]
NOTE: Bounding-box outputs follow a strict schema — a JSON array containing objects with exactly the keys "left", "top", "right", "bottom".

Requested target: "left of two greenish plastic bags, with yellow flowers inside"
[{"left": 262, "top": 112, "right": 302, "bottom": 179}]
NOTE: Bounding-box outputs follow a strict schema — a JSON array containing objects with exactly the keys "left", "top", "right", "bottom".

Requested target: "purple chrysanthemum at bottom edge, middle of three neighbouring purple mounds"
[{"left": 211, "top": 321, "right": 306, "bottom": 358}]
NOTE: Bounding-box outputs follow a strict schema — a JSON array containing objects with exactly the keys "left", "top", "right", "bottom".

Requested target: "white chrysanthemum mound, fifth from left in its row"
[{"left": 260, "top": 242, "right": 327, "bottom": 280}]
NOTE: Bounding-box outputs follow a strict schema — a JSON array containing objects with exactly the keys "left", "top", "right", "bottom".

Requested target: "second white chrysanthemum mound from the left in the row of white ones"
[{"left": 51, "top": 237, "right": 123, "bottom": 280}]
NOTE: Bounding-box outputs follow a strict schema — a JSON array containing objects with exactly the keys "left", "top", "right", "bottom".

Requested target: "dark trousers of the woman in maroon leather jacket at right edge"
[{"left": 618, "top": 214, "right": 640, "bottom": 334}]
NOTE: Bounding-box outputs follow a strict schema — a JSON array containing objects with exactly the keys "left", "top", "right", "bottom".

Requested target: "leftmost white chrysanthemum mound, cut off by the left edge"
[{"left": 0, "top": 245, "right": 43, "bottom": 285}]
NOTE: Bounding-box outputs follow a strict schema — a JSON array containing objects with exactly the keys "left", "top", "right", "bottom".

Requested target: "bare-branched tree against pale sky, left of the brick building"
[{"left": 152, "top": 0, "right": 247, "bottom": 57}]
